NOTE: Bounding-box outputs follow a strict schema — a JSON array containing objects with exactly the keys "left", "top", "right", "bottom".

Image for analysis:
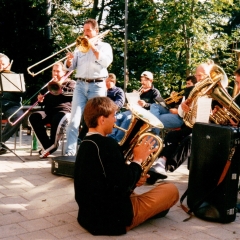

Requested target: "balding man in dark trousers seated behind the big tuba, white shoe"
[{"left": 147, "top": 61, "right": 214, "bottom": 184}]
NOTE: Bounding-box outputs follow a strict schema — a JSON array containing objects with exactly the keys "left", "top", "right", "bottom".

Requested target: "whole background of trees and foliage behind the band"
[{"left": 0, "top": 0, "right": 240, "bottom": 100}]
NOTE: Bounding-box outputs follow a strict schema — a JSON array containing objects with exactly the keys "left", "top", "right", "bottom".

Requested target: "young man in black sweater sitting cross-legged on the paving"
[{"left": 74, "top": 97, "right": 179, "bottom": 235}]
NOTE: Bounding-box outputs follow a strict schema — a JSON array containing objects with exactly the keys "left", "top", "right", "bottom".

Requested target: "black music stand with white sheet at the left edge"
[{"left": 0, "top": 73, "right": 26, "bottom": 162}]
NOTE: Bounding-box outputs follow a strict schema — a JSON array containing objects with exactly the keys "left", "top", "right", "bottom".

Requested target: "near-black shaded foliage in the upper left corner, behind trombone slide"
[{"left": 0, "top": 0, "right": 53, "bottom": 102}]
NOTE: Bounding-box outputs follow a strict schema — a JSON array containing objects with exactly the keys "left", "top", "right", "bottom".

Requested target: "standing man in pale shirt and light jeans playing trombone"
[{"left": 65, "top": 19, "right": 113, "bottom": 156}]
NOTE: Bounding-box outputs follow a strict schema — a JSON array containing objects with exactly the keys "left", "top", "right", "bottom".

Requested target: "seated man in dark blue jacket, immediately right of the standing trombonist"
[{"left": 106, "top": 73, "right": 125, "bottom": 110}]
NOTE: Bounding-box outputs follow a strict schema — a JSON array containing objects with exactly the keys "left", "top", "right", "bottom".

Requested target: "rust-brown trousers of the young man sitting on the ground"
[{"left": 126, "top": 183, "right": 179, "bottom": 231}]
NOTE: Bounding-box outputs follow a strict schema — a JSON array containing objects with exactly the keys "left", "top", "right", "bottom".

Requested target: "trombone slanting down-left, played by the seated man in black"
[{"left": 8, "top": 70, "right": 73, "bottom": 126}]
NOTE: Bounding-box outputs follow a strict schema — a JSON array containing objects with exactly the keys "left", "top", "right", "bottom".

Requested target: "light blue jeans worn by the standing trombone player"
[{"left": 65, "top": 80, "right": 107, "bottom": 156}]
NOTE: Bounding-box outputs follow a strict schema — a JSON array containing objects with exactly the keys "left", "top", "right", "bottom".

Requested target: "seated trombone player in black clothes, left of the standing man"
[{"left": 29, "top": 62, "right": 75, "bottom": 158}]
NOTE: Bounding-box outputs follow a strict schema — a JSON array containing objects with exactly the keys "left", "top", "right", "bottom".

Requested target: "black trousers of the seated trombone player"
[{"left": 29, "top": 112, "right": 66, "bottom": 150}]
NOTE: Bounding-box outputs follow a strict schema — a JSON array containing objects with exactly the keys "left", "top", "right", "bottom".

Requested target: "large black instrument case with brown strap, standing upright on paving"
[{"left": 180, "top": 123, "right": 240, "bottom": 223}]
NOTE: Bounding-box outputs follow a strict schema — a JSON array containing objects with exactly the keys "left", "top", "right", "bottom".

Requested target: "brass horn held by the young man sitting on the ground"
[{"left": 115, "top": 104, "right": 164, "bottom": 175}]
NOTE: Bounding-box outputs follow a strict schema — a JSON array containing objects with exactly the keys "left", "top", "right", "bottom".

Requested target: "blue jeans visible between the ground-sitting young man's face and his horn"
[{"left": 108, "top": 111, "right": 132, "bottom": 142}]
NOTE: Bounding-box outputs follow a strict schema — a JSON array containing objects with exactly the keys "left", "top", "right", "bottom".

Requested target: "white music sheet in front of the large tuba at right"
[{"left": 196, "top": 97, "right": 212, "bottom": 123}]
